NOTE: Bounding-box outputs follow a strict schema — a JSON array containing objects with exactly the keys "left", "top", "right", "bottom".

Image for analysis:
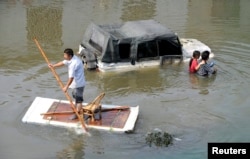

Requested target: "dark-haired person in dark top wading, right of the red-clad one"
[{"left": 197, "top": 51, "right": 217, "bottom": 76}]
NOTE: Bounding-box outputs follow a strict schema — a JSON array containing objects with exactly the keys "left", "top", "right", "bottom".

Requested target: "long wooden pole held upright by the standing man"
[{"left": 34, "top": 38, "right": 87, "bottom": 132}]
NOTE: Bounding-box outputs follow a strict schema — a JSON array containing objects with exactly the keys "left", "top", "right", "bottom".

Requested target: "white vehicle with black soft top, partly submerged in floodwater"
[{"left": 79, "top": 20, "right": 213, "bottom": 71}]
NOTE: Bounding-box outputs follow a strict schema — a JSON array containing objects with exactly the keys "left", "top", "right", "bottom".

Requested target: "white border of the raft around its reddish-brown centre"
[{"left": 22, "top": 97, "right": 139, "bottom": 132}]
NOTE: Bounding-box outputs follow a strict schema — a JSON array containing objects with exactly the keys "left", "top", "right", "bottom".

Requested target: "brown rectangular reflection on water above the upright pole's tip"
[{"left": 26, "top": 5, "right": 63, "bottom": 48}]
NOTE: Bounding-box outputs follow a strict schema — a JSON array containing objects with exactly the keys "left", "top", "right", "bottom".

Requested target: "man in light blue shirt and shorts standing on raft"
[{"left": 48, "top": 48, "right": 85, "bottom": 120}]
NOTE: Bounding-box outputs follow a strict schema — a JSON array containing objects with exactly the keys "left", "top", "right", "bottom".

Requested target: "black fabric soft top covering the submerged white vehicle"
[{"left": 81, "top": 20, "right": 182, "bottom": 63}]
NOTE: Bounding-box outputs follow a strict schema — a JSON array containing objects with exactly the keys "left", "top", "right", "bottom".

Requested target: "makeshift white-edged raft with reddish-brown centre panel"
[{"left": 22, "top": 97, "right": 139, "bottom": 132}]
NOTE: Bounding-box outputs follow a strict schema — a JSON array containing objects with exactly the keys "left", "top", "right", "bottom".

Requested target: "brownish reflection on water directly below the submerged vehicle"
[{"left": 91, "top": 67, "right": 164, "bottom": 96}]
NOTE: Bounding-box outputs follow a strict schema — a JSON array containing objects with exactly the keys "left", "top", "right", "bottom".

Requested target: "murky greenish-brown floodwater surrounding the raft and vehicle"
[{"left": 0, "top": 0, "right": 250, "bottom": 159}]
